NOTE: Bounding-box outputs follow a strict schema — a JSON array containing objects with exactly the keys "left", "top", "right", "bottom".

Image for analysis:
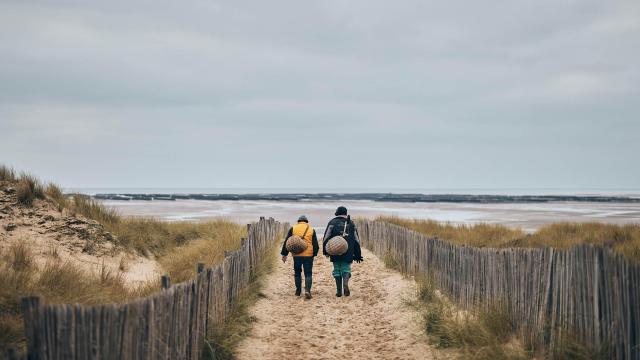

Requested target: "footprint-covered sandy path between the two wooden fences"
[{"left": 236, "top": 249, "right": 435, "bottom": 359}]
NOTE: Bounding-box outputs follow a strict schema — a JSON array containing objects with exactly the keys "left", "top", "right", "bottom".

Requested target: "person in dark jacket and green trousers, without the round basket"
[{"left": 322, "top": 206, "right": 364, "bottom": 297}]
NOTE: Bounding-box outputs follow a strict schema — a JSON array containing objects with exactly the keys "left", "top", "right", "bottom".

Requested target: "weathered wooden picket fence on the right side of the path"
[{"left": 358, "top": 221, "right": 640, "bottom": 359}]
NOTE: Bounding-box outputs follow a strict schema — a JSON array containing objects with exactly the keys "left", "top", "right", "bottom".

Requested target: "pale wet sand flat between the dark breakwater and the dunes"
[{"left": 103, "top": 200, "right": 640, "bottom": 231}]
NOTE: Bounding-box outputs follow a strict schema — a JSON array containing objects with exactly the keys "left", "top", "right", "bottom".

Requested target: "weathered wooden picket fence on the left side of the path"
[{"left": 23, "top": 218, "right": 285, "bottom": 359}]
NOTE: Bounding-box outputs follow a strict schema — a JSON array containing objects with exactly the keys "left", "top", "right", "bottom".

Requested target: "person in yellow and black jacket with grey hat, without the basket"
[{"left": 280, "top": 215, "right": 320, "bottom": 299}]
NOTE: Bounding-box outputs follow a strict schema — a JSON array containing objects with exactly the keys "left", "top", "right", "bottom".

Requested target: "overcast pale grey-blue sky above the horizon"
[{"left": 0, "top": 0, "right": 640, "bottom": 189}]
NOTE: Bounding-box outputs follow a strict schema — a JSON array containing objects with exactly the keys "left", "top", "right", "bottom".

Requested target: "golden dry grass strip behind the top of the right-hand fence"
[{"left": 376, "top": 217, "right": 640, "bottom": 261}]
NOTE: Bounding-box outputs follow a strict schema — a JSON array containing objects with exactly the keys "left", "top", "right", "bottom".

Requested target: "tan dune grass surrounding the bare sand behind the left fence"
[{"left": 0, "top": 165, "right": 255, "bottom": 356}]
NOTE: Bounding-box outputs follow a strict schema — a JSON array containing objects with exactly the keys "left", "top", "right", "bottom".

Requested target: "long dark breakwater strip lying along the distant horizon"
[{"left": 93, "top": 193, "right": 640, "bottom": 204}]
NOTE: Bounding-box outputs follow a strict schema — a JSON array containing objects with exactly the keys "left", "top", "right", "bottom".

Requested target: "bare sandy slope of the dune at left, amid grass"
[{"left": 0, "top": 181, "right": 160, "bottom": 287}]
